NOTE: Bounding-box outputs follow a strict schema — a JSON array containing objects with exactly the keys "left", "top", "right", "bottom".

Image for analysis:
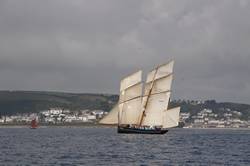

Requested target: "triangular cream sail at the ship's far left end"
[{"left": 99, "top": 105, "right": 119, "bottom": 125}]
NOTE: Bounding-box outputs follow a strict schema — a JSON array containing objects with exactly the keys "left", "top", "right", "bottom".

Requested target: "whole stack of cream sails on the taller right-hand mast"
[{"left": 141, "top": 61, "right": 174, "bottom": 126}]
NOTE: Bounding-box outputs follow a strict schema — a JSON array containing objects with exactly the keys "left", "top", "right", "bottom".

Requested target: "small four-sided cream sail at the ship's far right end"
[{"left": 163, "top": 107, "right": 180, "bottom": 128}]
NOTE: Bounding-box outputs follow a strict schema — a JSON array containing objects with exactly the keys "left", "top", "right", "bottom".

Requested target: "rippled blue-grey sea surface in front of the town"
[{"left": 0, "top": 127, "right": 250, "bottom": 166}]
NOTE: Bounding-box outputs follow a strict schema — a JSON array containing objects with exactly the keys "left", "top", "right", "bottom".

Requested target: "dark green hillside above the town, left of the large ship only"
[{"left": 0, "top": 91, "right": 118, "bottom": 115}]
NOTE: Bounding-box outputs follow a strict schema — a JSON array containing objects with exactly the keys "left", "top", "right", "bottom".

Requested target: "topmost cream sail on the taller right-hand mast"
[{"left": 146, "top": 61, "right": 174, "bottom": 83}]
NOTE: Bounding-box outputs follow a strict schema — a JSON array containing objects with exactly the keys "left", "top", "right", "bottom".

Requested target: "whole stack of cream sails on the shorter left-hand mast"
[{"left": 118, "top": 71, "right": 142, "bottom": 124}]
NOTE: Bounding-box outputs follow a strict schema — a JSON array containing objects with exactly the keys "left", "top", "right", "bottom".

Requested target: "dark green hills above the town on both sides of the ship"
[{"left": 0, "top": 91, "right": 250, "bottom": 120}]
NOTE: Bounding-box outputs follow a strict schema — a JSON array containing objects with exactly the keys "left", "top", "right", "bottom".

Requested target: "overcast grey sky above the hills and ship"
[{"left": 0, "top": 0, "right": 250, "bottom": 104}]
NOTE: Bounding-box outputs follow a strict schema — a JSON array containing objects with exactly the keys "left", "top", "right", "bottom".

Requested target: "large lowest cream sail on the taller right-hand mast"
[{"left": 141, "top": 92, "right": 170, "bottom": 126}]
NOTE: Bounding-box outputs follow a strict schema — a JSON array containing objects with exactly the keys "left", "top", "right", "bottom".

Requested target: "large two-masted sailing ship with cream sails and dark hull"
[{"left": 100, "top": 61, "right": 180, "bottom": 134}]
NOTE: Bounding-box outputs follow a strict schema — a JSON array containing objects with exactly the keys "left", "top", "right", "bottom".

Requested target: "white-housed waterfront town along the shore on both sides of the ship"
[{"left": 0, "top": 108, "right": 250, "bottom": 128}]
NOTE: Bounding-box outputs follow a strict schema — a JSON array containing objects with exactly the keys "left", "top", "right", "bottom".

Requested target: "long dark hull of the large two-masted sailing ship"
[{"left": 117, "top": 127, "right": 168, "bottom": 134}]
